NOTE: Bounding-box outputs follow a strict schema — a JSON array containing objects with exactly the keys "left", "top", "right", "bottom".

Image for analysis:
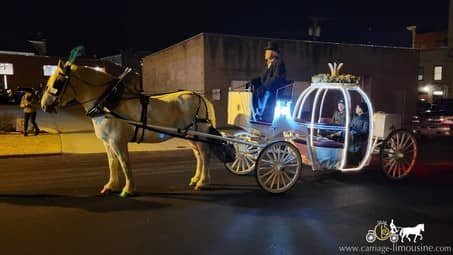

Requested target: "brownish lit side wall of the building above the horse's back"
[{"left": 143, "top": 34, "right": 205, "bottom": 93}]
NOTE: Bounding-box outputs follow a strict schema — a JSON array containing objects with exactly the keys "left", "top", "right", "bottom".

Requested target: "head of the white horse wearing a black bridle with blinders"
[{"left": 41, "top": 61, "right": 74, "bottom": 112}]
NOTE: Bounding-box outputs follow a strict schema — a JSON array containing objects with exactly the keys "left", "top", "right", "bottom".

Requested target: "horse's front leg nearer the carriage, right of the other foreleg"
[{"left": 110, "top": 139, "right": 135, "bottom": 197}]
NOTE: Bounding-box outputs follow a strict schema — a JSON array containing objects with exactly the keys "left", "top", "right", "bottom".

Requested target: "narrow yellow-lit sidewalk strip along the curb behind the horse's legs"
[{"left": 0, "top": 132, "right": 190, "bottom": 157}]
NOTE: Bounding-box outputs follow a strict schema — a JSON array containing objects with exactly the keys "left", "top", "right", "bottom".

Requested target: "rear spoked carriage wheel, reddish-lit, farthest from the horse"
[{"left": 380, "top": 129, "right": 417, "bottom": 180}]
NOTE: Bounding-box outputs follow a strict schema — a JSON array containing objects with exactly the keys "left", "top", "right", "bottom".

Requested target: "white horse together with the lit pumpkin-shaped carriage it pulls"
[{"left": 41, "top": 50, "right": 417, "bottom": 196}]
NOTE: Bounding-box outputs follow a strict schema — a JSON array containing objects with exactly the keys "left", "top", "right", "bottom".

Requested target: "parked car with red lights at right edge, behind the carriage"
[{"left": 412, "top": 99, "right": 453, "bottom": 136}]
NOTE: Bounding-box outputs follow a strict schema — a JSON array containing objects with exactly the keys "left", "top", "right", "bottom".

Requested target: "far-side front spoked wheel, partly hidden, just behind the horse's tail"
[{"left": 225, "top": 132, "right": 260, "bottom": 175}]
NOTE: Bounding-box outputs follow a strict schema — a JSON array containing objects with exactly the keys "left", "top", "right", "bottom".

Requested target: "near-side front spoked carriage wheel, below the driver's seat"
[{"left": 255, "top": 141, "right": 302, "bottom": 193}]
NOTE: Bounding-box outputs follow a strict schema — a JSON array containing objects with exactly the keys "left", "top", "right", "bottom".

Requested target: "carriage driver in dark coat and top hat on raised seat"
[{"left": 246, "top": 41, "right": 286, "bottom": 122}]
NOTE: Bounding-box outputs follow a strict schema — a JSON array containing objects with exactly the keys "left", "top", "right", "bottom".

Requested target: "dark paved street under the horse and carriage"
[{"left": 0, "top": 139, "right": 453, "bottom": 255}]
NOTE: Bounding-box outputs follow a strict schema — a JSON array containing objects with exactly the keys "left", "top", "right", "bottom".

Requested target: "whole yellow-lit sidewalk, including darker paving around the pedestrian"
[{"left": 0, "top": 106, "right": 190, "bottom": 157}]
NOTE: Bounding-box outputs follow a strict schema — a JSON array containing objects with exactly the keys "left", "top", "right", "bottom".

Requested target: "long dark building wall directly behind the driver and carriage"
[{"left": 205, "top": 34, "right": 419, "bottom": 125}]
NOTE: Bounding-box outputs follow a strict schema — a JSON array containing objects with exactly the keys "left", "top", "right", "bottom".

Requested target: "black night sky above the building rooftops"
[{"left": 0, "top": 0, "right": 449, "bottom": 57}]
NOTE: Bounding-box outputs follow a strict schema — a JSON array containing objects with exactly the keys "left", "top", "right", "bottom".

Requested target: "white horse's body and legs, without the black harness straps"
[{"left": 41, "top": 61, "right": 215, "bottom": 197}]
